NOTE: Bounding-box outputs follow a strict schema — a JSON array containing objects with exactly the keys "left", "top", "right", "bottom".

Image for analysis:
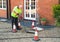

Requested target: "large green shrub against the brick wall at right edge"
[{"left": 53, "top": 5, "right": 60, "bottom": 25}]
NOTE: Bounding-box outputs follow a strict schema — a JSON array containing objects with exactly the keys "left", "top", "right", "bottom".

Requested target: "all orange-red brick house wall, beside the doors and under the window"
[{"left": 0, "top": 0, "right": 58, "bottom": 25}]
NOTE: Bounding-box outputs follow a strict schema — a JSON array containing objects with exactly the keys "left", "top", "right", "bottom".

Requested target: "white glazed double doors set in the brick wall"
[{"left": 24, "top": 0, "right": 36, "bottom": 20}]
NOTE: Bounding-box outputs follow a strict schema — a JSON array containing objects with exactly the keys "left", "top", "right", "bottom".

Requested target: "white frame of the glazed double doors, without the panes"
[{"left": 24, "top": 0, "right": 36, "bottom": 20}]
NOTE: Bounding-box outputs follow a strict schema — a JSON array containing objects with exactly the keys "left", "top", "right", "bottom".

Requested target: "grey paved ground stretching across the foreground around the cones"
[{"left": 0, "top": 22, "right": 60, "bottom": 42}]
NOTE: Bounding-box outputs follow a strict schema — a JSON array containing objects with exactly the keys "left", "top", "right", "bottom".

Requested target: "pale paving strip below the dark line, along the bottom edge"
[{"left": 0, "top": 38, "right": 60, "bottom": 42}]
